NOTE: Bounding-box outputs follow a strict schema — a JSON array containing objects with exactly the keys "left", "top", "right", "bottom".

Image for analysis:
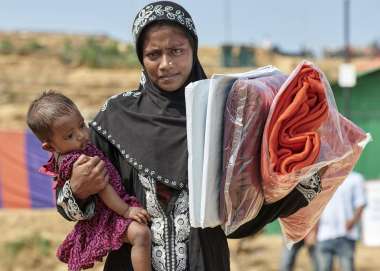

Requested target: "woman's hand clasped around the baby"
[{"left": 70, "top": 154, "right": 108, "bottom": 199}]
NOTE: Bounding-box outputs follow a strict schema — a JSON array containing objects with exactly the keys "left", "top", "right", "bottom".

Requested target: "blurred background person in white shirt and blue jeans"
[{"left": 317, "top": 172, "right": 367, "bottom": 271}]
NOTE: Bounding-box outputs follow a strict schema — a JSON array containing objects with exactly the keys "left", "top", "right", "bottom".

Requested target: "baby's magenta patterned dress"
[{"left": 42, "top": 144, "right": 140, "bottom": 271}]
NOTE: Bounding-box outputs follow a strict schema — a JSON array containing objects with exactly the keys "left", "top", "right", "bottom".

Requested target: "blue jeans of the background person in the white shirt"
[{"left": 317, "top": 237, "right": 355, "bottom": 271}]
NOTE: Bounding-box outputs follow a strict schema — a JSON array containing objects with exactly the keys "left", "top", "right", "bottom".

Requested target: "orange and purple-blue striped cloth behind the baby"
[{"left": 0, "top": 131, "right": 55, "bottom": 208}]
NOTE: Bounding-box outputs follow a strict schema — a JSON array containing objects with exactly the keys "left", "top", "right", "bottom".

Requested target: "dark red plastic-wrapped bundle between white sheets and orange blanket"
[{"left": 220, "top": 72, "right": 286, "bottom": 234}]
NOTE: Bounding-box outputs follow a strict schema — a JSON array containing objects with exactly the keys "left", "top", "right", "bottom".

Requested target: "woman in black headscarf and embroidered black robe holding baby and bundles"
[{"left": 57, "top": 1, "right": 320, "bottom": 271}]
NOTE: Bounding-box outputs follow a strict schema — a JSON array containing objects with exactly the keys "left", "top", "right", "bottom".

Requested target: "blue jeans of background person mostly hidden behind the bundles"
[{"left": 280, "top": 240, "right": 319, "bottom": 271}]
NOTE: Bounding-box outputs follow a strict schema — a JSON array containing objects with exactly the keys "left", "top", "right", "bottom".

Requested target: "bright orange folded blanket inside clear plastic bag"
[{"left": 267, "top": 65, "right": 328, "bottom": 174}]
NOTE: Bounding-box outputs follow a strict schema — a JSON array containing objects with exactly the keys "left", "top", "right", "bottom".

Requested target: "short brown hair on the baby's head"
[{"left": 26, "top": 90, "right": 78, "bottom": 142}]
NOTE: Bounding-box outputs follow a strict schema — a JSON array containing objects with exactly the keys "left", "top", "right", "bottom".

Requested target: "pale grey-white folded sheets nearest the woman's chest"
[{"left": 185, "top": 66, "right": 279, "bottom": 228}]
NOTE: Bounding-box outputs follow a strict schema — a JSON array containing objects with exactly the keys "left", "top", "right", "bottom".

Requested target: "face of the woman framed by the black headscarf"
[{"left": 142, "top": 25, "right": 193, "bottom": 92}]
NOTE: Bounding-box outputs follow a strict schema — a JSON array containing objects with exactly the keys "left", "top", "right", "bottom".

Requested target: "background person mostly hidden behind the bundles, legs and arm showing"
[{"left": 280, "top": 226, "right": 319, "bottom": 271}]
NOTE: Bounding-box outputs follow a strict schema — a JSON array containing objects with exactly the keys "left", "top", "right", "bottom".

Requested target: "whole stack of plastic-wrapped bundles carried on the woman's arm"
[{"left": 189, "top": 61, "right": 370, "bottom": 240}]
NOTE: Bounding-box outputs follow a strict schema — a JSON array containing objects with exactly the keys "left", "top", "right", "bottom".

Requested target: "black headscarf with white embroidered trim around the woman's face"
[{"left": 91, "top": 1, "right": 206, "bottom": 189}]
